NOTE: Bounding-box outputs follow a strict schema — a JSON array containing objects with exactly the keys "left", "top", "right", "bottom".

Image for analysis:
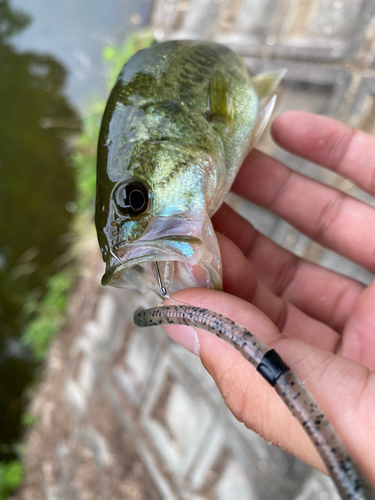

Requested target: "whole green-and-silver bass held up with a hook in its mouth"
[{"left": 95, "top": 40, "right": 283, "bottom": 293}]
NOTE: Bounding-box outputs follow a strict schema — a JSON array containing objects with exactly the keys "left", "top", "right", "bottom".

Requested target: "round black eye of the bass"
[{"left": 115, "top": 181, "right": 149, "bottom": 215}]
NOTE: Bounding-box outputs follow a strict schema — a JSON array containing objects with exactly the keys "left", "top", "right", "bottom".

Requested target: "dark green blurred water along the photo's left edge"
[{"left": 0, "top": 1, "right": 79, "bottom": 460}]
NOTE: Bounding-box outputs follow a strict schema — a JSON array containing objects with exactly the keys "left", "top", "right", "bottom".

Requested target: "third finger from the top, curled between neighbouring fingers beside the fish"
[{"left": 212, "top": 204, "right": 365, "bottom": 332}]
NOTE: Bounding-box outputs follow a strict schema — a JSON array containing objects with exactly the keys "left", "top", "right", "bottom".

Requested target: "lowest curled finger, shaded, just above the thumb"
[{"left": 217, "top": 234, "right": 341, "bottom": 352}]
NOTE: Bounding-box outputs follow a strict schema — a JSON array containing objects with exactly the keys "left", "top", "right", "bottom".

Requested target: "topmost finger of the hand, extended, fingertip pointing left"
[{"left": 272, "top": 111, "right": 375, "bottom": 194}]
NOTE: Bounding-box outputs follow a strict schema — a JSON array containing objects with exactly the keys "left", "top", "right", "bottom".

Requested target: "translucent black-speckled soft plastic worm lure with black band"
[{"left": 134, "top": 299, "right": 375, "bottom": 500}]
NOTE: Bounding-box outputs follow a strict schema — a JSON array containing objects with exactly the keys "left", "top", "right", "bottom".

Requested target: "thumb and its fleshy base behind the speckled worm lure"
[{"left": 163, "top": 289, "right": 375, "bottom": 483}]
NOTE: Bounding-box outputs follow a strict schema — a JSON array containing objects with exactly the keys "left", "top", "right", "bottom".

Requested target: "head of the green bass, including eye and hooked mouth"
[{"left": 96, "top": 137, "right": 225, "bottom": 293}]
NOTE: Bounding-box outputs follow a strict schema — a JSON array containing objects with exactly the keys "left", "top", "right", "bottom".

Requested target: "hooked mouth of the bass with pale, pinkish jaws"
[{"left": 102, "top": 218, "right": 222, "bottom": 295}]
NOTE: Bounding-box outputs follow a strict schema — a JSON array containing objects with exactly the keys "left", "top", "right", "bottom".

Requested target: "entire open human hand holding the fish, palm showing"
[{"left": 165, "top": 112, "right": 375, "bottom": 487}]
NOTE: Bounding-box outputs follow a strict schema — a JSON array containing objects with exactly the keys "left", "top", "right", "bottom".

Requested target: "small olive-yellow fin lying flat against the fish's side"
[{"left": 208, "top": 72, "right": 233, "bottom": 127}]
